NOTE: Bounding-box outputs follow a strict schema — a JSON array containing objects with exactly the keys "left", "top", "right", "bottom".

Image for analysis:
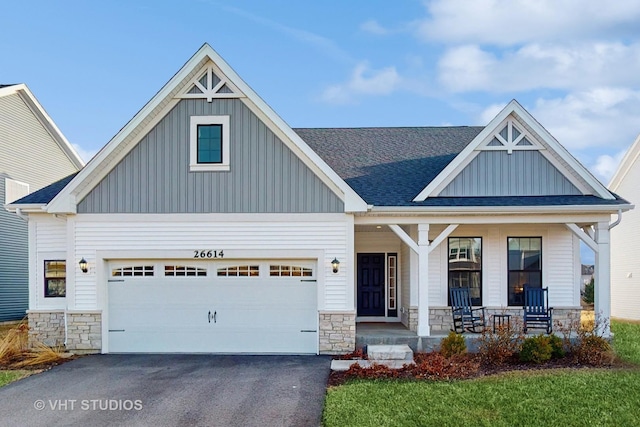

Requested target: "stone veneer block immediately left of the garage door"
[{"left": 67, "top": 312, "right": 102, "bottom": 354}]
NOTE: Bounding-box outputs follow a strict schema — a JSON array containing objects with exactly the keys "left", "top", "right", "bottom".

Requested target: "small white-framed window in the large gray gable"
[{"left": 189, "top": 116, "right": 230, "bottom": 171}]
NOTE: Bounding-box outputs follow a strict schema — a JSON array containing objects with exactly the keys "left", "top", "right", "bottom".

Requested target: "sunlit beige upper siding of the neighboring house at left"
[{"left": 0, "top": 94, "right": 78, "bottom": 193}]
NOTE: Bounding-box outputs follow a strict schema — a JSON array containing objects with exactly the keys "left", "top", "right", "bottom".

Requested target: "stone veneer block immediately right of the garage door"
[{"left": 318, "top": 311, "right": 356, "bottom": 354}]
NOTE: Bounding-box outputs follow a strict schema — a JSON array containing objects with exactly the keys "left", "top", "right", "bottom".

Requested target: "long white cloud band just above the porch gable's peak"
[{"left": 438, "top": 42, "right": 640, "bottom": 93}]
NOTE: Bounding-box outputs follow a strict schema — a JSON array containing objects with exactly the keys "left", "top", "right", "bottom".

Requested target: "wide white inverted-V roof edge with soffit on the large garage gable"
[{"left": 47, "top": 43, "right": 367, "bottom": 213}]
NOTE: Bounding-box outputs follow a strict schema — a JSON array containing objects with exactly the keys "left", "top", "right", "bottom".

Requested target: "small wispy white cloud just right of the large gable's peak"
[{"left": 322, "top": 62, "right": 402, "bottom": 104}]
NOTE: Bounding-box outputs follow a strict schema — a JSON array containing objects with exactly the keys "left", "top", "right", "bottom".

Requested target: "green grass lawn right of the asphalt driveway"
[{"left": 323, "top": 321, "right": 640, "bottom": 427}]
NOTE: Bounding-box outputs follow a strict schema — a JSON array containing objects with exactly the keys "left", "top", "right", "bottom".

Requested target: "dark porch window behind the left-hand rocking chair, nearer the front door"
[{"left": 447, "top": 237, "right": 482, "bottom": 305}]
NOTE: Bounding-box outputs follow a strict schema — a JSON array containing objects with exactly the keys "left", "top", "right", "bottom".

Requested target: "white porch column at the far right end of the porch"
[{"left": 594, "top": 222, "right": 611, "bottom": 337}]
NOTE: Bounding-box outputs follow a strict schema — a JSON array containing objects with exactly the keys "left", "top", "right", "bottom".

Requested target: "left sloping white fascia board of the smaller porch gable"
[{"left": 413, "top": 100, "right": 516, "bottom": 202}]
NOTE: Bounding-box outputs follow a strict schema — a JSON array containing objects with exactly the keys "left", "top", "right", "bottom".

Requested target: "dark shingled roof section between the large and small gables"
[{"left": 294, "top": 126, "right": 483, "bottom": 206}]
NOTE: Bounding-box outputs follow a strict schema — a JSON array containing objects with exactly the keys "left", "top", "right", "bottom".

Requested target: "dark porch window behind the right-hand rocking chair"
[{"left": 507, "top": 237, "right": 542, "bottom": 305}]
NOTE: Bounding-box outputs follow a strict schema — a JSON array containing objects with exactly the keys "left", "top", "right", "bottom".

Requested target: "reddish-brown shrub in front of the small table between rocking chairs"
[{"left": 477, "top": 318, "right": 524, "bottom": 365}]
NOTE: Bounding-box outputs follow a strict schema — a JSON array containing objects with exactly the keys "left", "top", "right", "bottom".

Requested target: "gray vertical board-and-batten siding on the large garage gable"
[{"left": 78, "top": 99, "right": 344, "bottom": 213}]
